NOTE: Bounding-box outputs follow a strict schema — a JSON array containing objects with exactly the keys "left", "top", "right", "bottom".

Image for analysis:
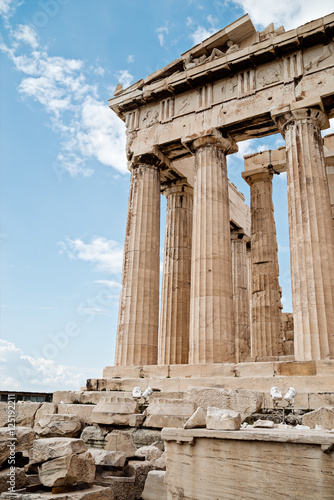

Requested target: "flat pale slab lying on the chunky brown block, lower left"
[{"left": 32, "top": 437, "right": 87, "bottom": 463}]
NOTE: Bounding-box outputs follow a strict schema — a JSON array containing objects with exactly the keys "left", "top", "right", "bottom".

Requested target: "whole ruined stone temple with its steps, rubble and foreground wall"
[{"left": 0, "top": 14, "right": 334, "bottom": 500}]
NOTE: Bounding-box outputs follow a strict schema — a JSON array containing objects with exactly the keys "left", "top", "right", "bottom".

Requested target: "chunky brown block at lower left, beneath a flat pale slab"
[{"left": 38, "top": 451, "right": 95, "bottom": 487}]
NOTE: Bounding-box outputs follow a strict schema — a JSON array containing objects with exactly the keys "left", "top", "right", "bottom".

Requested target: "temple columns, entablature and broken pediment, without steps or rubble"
[{"left": 103, "top": 11, "right": 334, "bottom": 376}]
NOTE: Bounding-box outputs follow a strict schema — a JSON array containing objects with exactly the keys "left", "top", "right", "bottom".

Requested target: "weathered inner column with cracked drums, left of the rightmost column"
[{"left": 243, "top": 170, "right": 283, "bottom": 361}]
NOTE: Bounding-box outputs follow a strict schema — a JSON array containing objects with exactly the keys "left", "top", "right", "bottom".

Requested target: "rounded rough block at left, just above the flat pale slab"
[{"left": 34, "top": 413, "right": 82, "bottom": 437}]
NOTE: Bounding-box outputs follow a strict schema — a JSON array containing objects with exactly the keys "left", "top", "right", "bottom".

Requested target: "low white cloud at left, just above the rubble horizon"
[{"left": 0, "top": 338, "right": 99, "bottom": 392}]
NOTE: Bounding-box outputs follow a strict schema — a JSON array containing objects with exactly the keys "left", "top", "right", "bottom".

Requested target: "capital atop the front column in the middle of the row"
[{"left": 182, "top": 128, "right": 238, "bottom": 155}]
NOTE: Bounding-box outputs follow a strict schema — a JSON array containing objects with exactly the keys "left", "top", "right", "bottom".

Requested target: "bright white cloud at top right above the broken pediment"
[{"left": 232, "top": 0, "right": 333, "bottom": 30}]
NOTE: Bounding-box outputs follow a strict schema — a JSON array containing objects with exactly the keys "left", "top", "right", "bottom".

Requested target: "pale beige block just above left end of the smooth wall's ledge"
[{"left": 143, "top": 399, "right": 196, "bottom": 429}]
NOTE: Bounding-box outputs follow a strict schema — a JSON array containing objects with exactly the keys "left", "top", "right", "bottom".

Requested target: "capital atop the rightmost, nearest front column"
[{"left": 271, "top": 105, "right": 329, "bottom": 137}]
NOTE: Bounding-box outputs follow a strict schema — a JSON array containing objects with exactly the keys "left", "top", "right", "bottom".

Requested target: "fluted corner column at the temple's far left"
[{"left": 115, "top": 155, "right": 160, "bottom": 366}]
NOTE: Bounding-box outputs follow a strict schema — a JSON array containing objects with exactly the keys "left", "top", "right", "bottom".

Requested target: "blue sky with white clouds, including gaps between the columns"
[{"left": 0, "top": 0, "right": 333, "bottom": 392}]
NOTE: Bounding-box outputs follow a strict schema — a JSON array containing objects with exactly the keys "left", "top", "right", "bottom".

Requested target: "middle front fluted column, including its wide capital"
[{"left": 189, "top": 132, "right": 237, "bottom": 364}]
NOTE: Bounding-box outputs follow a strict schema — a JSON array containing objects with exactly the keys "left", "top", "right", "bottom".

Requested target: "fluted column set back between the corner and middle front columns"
[{"left": 158, "top": 181, "right": 193, "bottom": 365}]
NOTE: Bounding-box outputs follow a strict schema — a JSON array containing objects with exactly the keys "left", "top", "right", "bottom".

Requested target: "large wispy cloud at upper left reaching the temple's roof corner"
[{"left": 0, "top": 21, "right": 126, "bottom": 176}]
